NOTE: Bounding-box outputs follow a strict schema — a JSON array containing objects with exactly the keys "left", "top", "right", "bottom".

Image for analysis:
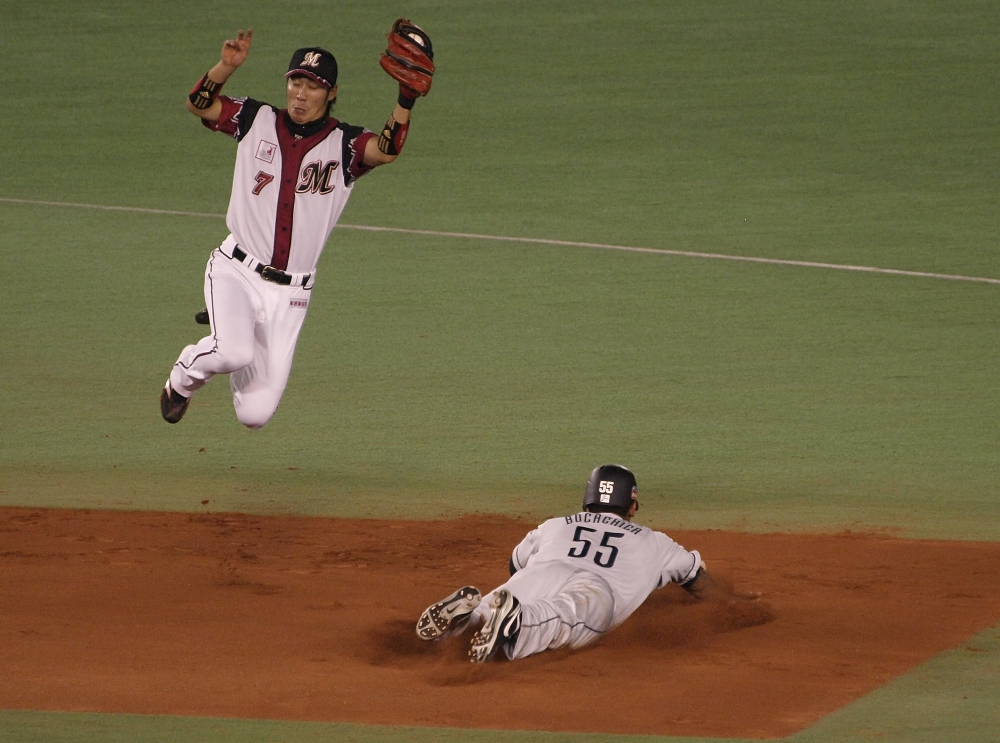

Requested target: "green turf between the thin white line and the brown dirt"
[{"left": 0, "top": 211, "right": 1000, "bottom": 539}]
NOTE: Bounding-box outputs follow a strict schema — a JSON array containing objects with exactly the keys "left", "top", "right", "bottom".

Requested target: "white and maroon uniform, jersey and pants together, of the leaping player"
[{"left": 169, "top": 96, "right": 375, "bottom": 428}]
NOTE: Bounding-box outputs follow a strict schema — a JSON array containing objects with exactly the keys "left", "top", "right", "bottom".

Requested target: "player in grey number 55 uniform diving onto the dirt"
[{"left": 417, "top": 464, "right": 758, "bottom": 663}]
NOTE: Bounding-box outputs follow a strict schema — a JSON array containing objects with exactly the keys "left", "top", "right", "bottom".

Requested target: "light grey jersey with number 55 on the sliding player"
[{"left": 511, "top": 512, "right": 702, "bottom": 627}]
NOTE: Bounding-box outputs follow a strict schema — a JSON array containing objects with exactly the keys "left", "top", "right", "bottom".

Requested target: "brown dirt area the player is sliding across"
[{"left": 0, "top": 509, "right": 1000, "bottom": 738}]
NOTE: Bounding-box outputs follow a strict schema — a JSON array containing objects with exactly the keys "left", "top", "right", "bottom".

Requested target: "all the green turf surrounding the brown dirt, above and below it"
[{"left": 0, "top": 0, "right": 1000, "bottom": 743}]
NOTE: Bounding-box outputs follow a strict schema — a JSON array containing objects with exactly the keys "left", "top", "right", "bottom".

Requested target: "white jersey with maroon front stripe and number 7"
[{"left": 203, "top": 96, "right": 375, "bottom": 273}]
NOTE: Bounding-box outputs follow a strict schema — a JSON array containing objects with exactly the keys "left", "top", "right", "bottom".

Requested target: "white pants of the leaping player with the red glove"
[{"left": 170, "top": 249, "right": 311, "bottom": 428}]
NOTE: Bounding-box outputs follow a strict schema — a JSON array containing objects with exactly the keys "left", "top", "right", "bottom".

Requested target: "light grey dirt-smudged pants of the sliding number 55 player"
[{"left": 471, "top": 562, "right": 615, "bottom": 660}]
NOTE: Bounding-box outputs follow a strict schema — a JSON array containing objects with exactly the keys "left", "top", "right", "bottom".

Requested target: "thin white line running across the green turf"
[{"left": 0, "top": 197, "right": 1000, "bottom": 284}]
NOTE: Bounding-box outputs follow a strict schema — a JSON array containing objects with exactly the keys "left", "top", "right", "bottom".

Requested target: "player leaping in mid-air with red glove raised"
[{"left": 160, "top": 18, "right": 434, "bottom": 428}]
